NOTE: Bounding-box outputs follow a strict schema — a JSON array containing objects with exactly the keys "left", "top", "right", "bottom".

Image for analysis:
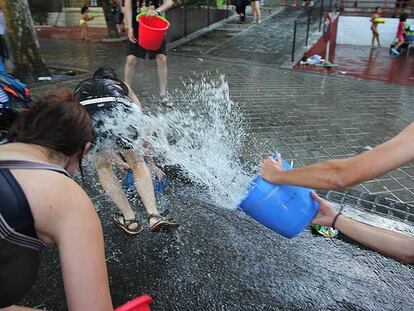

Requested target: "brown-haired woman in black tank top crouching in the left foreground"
[{"left": 0, "top": 89, "right": 113, "bottom": 310}]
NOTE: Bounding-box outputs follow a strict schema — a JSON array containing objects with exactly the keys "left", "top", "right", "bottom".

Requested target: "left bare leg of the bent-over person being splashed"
[{"left": 96, "top": 152, "right": 137, "bottom": 224}]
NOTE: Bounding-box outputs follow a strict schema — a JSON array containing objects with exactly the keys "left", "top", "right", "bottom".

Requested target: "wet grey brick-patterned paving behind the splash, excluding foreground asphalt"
[{"left": 35, "top": 17, "right": 414, "bottom": 214}]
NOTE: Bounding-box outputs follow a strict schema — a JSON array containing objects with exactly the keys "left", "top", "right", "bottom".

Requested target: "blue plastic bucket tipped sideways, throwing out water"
[{"left": 239, "top": 161, "right": 319, "bottom": 238}]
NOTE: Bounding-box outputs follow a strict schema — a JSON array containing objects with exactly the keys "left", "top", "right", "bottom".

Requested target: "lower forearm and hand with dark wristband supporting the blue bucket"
[{"left": 312, "top": 193, "right": 414, "bottom": 264}]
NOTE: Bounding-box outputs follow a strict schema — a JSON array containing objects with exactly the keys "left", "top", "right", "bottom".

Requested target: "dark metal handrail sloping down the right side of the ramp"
[{"left": 291, "top": 0, "right": 336, "bottom": 62}]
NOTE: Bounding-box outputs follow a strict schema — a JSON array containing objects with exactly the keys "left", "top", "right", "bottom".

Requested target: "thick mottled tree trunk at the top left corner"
[{"left": 4, "top": 0, "right": 49, "bottom": 79}]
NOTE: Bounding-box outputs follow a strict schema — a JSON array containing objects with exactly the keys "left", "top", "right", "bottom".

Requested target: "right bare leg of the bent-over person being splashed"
[{"left": 122, "top": 149, "right": 158, "bottom": 226}]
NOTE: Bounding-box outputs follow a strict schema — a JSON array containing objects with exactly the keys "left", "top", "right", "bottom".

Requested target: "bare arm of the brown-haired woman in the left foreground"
[{"left": 51, "top": 180, "right": 113, "bottom": 311}]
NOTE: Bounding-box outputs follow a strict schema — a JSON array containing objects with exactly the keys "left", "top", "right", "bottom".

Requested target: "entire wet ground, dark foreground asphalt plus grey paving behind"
[{"left": 21, "top": 7, "right": 414, "bottom": 310}]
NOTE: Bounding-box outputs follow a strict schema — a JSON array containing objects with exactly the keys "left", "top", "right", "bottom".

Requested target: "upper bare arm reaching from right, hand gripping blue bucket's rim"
[{"left": 260, "top": 123, "right": 414, "bottom": 189}]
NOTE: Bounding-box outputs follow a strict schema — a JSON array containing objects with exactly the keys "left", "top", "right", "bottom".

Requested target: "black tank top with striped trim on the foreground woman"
[{"left": 0, "top": 161, "right": 69, "bottom": 308}]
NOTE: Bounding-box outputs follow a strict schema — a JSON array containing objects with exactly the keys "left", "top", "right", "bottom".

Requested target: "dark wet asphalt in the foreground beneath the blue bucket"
[{"left": 22, "top": 185, "right": 414, "bottom": 311}]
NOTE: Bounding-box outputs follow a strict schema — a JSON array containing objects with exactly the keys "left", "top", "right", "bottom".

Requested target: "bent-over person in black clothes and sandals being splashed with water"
[{"left": 75, "top": 67, "right": 178, "bottom": 234}]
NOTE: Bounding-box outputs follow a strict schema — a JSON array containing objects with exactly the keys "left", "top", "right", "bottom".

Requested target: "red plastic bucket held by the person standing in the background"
[{"left": 137, "top": 13, "right": 170, "bottom": 51}]
